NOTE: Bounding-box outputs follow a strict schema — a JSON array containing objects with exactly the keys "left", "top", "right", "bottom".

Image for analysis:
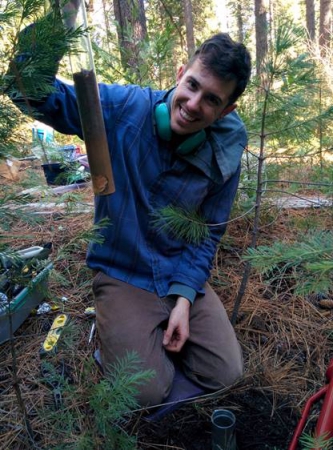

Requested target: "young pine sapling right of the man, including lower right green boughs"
[{"left": 232, "top": 20, "right": 333, "bottom": 322}]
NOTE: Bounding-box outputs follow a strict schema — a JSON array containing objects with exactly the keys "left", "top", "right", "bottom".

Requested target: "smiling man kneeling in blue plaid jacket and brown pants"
[{"left": 9, "top": 25, "right": 251, "bottom": 406}]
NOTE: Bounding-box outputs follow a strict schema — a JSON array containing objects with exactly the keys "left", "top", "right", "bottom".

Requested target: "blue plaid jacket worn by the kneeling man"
[{"left": 39, "top": 80, "right": 247, "bottom": 302}]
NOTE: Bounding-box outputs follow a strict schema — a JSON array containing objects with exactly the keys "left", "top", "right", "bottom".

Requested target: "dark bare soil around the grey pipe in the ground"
[{"left": 134, "top": 388, "right": 299, "bottom": 450}]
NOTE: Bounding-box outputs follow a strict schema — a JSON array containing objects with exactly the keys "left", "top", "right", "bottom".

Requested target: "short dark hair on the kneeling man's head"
[{"left": 187, "top": 33, "right": 251, "bottom": 104}]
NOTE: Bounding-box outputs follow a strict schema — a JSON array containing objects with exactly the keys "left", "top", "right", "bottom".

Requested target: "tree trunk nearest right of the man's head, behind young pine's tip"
[{"left": 254, "top": 0, "right": 268, "bottom": 75}]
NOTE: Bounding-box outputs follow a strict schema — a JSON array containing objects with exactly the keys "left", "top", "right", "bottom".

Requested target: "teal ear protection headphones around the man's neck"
[{"left": 155, "top": 103, "right": 206, "bottom": 155}]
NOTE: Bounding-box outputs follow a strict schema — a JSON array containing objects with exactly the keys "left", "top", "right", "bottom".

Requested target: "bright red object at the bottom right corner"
[{"left": 288, "top": 359, "right": 333, "bottom": 450}]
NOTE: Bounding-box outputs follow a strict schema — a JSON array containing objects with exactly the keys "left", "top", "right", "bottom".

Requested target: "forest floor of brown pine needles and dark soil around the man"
[{"left": 0, "top": 166, "right": 333, "bottom": 450}]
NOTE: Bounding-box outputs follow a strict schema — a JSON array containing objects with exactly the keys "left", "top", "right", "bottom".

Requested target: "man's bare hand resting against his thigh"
[{"left": 163, "top": 297, "right": 191, "bottom": 352}]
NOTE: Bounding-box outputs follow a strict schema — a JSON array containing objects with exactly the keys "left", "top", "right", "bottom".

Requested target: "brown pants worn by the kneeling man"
[{"left": 93, "top": 272, "right": 243, "bottom": 406}]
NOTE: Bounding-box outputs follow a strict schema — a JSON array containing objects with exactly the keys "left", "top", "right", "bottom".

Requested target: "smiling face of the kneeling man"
[{"left": 171, "top": 59, "right": 236, "bottom": 135}]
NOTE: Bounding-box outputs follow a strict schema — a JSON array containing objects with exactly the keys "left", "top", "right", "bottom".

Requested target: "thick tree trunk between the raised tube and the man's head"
[{"left": 113, "top": 0, "right": 147, "bottom": 75}]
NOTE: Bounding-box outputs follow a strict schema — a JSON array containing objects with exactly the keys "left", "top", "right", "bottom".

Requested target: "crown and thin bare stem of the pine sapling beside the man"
[{"left": 231, "top": 20, "right": 332, "bottom": 324}]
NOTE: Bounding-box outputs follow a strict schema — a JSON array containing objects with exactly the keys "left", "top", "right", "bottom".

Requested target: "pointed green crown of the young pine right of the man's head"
[{"left": 242, "top": 21, "right": 333, "bottom": 149}]
